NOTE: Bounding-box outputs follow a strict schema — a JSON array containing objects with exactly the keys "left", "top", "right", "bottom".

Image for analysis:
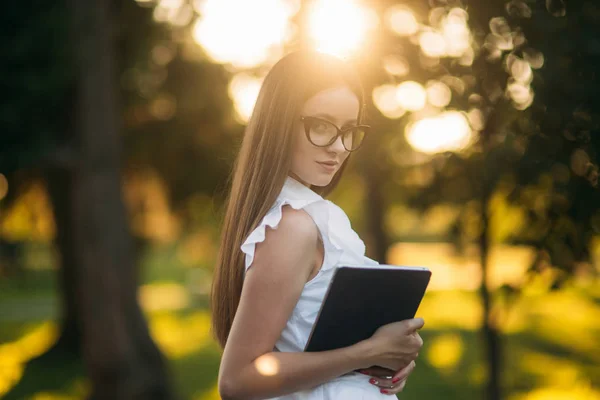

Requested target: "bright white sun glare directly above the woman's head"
[{"left": 308, "top": 0, "right": 378, "bottom": 57}]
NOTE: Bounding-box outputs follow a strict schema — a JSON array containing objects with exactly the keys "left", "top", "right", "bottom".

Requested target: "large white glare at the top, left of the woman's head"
[{"left": 193, "top": 0, "right": 298, "bottom": 68}]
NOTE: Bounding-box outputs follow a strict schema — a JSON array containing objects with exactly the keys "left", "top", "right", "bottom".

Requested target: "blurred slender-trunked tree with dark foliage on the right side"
[{"left": 386, "top": 1, "right": 600, "bottom": 399}]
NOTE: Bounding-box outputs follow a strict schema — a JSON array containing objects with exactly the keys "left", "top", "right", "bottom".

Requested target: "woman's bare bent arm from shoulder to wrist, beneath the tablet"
[{"left": 219, "top": 207, "right": 372, "bottom": 399}]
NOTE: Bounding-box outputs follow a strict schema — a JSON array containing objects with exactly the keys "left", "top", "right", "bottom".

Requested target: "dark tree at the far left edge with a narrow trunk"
[{"left": 0, "top": 1, "right": 80, "bottom": 360}]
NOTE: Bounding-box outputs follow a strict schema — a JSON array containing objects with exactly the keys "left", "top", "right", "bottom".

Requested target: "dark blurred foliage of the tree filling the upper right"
[{"left": 376, "top": 1, "right": 600, "bottom": 280}]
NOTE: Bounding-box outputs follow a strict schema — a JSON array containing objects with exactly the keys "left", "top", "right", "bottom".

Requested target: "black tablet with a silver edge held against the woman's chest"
[{"left": 304, "top": 265, "right": 431, "bottom": 352}]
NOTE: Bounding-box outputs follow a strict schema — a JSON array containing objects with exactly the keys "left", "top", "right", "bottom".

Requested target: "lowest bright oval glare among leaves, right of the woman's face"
[{"left": 406, "top": 111, "right": 472, "bottom": 154}]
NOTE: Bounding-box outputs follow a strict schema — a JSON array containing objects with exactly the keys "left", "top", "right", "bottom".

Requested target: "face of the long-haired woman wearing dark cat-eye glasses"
[{"left": 290, "top": 86, "right": 359, "bottom": 186}]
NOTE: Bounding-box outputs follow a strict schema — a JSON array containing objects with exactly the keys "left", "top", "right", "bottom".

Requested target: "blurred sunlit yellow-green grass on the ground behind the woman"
[{"left": 0, "top": 242, "right": 600, "bottom": 400}]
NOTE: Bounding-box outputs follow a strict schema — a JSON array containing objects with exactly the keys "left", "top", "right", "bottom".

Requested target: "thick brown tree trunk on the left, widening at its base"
[{"left": 68, "top": 0, "right": 171, "bottom": 400}]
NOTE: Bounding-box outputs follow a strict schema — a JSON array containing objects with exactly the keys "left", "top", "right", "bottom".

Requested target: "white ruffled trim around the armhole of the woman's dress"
[{"left": 240, "top": 197, "right": 343, "bottom": 274}]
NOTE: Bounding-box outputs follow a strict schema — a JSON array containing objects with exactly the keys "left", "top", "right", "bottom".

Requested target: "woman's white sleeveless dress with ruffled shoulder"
[{"left": 241, "top": 177, "right": 394, "bottom": 400}]
